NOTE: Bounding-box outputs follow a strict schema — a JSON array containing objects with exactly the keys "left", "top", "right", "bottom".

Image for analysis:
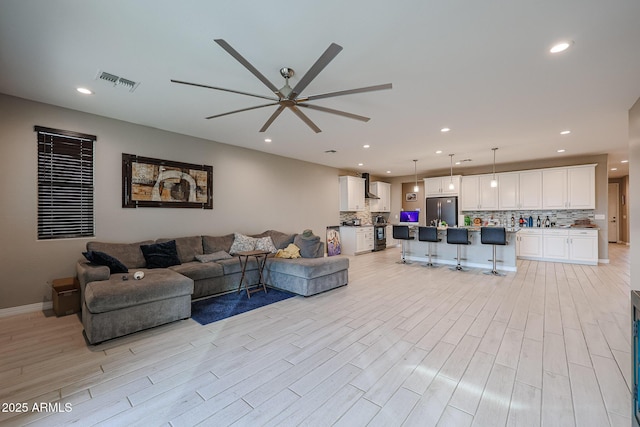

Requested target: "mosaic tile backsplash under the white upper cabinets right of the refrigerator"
[{"left": 462, "top": 209, "right": 595, "bottom": 227}]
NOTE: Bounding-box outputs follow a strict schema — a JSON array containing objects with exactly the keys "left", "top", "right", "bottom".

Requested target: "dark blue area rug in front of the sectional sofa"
[{"left": 191, "top": 288, "right": 296, "bottom": 325}]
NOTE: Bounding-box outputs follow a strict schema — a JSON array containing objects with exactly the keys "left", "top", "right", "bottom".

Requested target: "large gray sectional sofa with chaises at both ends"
[{"left": 76, "top": 230, "right": 349, "bottom": 344}]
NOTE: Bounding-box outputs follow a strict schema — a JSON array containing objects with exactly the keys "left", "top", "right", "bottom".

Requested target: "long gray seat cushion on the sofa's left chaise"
[{"left": 84, "top": 268, "right": 193, "bottom": 313}]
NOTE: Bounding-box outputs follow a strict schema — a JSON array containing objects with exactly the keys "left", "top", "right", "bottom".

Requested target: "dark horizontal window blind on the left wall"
[{"left": 35, "top": 126, "right": 96, "bottom": 240}]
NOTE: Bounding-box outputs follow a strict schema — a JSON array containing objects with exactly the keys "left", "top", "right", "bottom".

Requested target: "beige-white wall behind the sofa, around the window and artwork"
[{"left": 0, "top": 94, "right": 339, "bottom": 309}]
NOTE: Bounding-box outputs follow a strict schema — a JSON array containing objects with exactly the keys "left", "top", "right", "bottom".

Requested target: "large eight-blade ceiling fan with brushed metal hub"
[{"left": 171, "top": 39, "right": 391, "bottom": 133}]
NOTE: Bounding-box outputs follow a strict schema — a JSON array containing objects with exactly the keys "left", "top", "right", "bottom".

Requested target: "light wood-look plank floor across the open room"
[{"left": 0, "top": 245, "right": 631, "bottom": 427}]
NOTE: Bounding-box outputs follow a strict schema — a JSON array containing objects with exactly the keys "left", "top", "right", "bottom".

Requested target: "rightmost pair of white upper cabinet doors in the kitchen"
[{"left": 542, "top": 165, "right": 596, "bottom": 209}]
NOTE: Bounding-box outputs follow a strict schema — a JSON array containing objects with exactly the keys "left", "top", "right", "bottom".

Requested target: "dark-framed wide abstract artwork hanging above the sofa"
[{"left": 122, "top": 153, "right": 213, "bottom": 209}]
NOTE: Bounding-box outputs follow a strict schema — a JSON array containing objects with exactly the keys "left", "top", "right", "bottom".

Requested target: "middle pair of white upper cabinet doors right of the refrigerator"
[{"left": 498, "top": 170, "right": 542, "bottom": 210}]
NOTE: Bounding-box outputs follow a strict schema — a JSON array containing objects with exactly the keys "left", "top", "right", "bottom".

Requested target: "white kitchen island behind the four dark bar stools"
[{"left": 406, "top": 227, "right": 519, "bottom": 271}]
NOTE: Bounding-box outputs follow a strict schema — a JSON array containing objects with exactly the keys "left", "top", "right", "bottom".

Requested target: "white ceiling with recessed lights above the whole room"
[{"left": 0, "top": 0, "right": 640, "bottom": 176}]
